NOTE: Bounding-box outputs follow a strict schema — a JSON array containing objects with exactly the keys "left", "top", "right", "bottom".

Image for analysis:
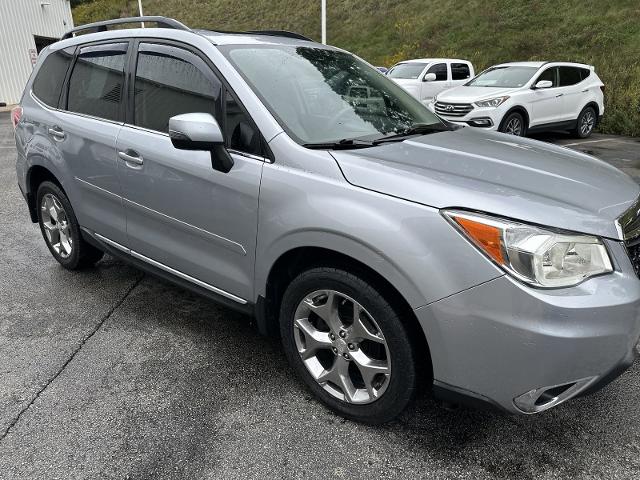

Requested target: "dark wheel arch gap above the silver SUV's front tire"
[{"left": 256, "top": 246, "right": 432, "bottom": 375}]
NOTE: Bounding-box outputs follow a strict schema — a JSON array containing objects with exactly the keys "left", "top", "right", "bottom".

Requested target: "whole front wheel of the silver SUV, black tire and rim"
[{"left": 280, "top": 267, "right": 417, "bottom": 424}]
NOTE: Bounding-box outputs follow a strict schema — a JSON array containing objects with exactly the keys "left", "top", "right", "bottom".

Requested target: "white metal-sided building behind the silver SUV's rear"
[{"left": 0, "top": 0, "right": 73, "bottom": 105}]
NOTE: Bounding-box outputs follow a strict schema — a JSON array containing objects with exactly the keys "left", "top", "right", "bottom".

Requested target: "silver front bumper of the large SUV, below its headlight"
[{"left": 416, "top": 242, "right": 640, "bottom": 414}]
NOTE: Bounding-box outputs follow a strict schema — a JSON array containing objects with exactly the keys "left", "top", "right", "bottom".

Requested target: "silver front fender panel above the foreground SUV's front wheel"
[{"left": 255, "top": 156, "right": 502, "bottom": 308}]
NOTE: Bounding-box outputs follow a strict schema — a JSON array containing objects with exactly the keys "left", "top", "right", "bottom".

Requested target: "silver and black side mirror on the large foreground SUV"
[{"left": 169, "top": 113, "right": 233, "bottom": 173}]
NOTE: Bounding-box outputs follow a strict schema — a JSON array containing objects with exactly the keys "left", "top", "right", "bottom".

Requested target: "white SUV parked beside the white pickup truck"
[{"left": 431, "top": 62, "right": 604, "bottom": 138}]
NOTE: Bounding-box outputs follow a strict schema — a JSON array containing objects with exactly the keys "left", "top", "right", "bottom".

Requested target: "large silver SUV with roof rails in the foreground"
[{"left": 12, "top": 17, "right": 640, "bottom": 423}]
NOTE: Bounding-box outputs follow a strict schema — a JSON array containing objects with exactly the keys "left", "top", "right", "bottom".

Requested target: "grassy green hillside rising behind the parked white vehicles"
[{"left": 74, "top": 0, "right": 640, "bottom": 136}]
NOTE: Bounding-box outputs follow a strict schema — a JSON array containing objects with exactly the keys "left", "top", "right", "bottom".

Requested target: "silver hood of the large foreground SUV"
[{"left": 331, "top": 127, "right": 640, "bottom": 238}]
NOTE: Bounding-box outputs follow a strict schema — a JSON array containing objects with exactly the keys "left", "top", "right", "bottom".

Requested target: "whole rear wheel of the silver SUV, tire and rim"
[{"left": 36, "top": 181, "right": 104, "bottom": 270}]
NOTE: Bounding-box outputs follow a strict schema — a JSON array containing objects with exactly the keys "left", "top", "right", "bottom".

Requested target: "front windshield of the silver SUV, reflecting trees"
[{"left": 219, "top": 45, "right": 446, "bottom": 144}]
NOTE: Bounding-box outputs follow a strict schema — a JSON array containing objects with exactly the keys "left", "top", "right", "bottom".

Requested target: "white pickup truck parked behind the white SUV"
[{"left": 387, "top": 58, "right": 475, "bottom": 105}]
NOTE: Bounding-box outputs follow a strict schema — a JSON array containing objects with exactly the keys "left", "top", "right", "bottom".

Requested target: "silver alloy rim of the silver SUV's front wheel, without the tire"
[{"left": 293, "top": 290, "right": 391, "bottom": 404}]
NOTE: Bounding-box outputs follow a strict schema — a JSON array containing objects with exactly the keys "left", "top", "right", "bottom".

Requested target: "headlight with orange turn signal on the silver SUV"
[{"left": 443, "top": 211, "right": 613, "bottom": 288}]
